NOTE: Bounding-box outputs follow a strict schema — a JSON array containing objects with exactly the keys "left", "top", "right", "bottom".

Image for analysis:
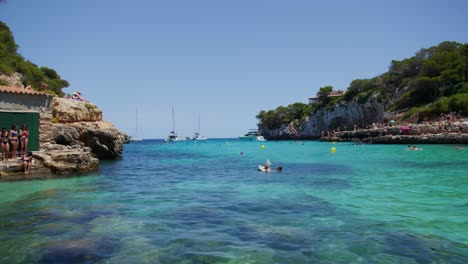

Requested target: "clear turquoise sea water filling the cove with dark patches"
[{"left": 0, "top": 139, "right": 468, "bottom": 263}]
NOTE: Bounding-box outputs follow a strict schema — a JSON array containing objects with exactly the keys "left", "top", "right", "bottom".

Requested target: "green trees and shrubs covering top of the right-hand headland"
[{"left": 257, "top": 41, "right": 468, "bottom": 129}]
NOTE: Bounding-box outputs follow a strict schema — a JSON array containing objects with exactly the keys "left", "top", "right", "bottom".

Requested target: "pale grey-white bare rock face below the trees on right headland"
[{"left": 260, "top": 97, "right": 385, "bottom": 139}]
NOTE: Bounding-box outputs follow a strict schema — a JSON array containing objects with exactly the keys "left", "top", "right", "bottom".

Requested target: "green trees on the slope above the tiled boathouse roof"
[{"left": 0, "top": 21, "right": 69, "bottom": 96}]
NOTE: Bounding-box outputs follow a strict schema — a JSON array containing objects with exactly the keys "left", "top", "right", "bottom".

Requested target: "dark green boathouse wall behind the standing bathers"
[{"left": 0, "top": 112, "right": 39, "bottom": 151}]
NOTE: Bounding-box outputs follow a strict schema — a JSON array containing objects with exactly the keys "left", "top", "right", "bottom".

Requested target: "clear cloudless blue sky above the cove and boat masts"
[{"left": 0, "top": 0, "right": 468, "bottom": 138}]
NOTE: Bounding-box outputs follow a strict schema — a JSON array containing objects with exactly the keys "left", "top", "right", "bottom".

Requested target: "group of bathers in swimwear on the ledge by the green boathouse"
[{"left": 0, "top": 124, "right": 33, "bottom": 174}]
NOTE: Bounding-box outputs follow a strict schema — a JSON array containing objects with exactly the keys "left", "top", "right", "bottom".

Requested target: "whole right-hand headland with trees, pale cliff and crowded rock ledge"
[{"left": 257, "top": 41, "right": 468, "bottom": 144}]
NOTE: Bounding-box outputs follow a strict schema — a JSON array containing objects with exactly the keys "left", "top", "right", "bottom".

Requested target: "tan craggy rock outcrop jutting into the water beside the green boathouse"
[{"left": 34, "top": 98, "right": 129, "bottom": 173}]
